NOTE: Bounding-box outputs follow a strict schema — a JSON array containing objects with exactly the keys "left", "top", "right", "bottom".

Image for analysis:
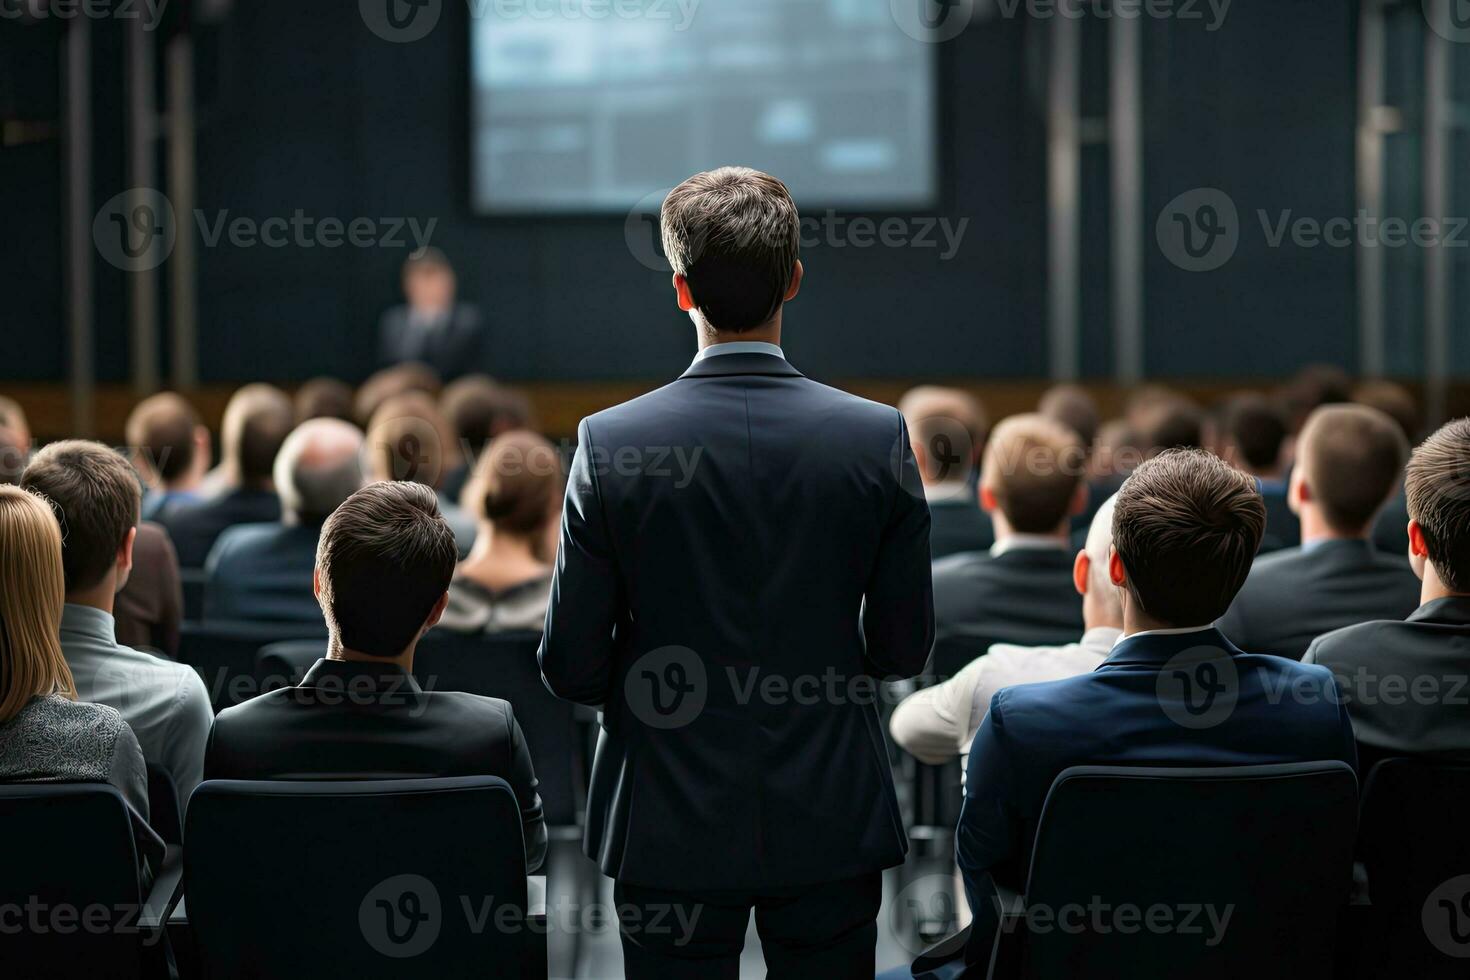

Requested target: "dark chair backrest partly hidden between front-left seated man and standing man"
[{"left": 413, "top": 629, "right": 587, "bottom": 826}]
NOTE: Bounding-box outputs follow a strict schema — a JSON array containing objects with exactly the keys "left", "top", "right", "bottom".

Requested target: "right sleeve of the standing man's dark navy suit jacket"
[{"left": 863, "top": 413, "right": 933, "bottom": 677}]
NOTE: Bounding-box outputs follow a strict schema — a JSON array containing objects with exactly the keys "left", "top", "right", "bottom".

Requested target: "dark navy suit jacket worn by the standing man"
[{"left": 539, "top": 353, "right": 933, "bottom": 890}]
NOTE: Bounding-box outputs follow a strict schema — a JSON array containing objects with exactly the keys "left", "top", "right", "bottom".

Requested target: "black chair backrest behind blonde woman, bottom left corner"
[{"left": 0, "top": 783, "right": 144, "bottom": 977}]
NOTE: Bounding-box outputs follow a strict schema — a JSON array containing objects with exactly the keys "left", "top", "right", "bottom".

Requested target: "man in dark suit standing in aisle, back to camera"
[{"left": 541, "top": 167, "right": 933, "bottom": 977}]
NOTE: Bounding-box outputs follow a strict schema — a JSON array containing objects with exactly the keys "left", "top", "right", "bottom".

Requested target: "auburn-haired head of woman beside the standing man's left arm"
[{"left": 465, "top": 429, "right": 562, "bottom": 538}]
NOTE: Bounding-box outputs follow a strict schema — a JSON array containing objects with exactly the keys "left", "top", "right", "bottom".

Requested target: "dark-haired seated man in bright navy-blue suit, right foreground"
[{"left": 956, "top": 450, "right": 1355, "bottom": 934}]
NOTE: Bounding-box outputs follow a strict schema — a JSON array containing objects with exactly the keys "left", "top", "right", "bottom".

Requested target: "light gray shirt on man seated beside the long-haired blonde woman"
[{"left": 62, "top": 602, "right": 215, "bottom": 813}]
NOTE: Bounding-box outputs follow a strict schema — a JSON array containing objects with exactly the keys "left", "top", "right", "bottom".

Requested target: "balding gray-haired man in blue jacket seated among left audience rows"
[{"left": 204, "top": 419, "right": 363, "bottom": 623}]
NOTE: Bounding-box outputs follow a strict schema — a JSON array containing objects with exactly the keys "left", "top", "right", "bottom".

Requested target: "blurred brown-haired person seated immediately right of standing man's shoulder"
[{"left": 898, "top": 385, "right": 995, "bottom": 560}]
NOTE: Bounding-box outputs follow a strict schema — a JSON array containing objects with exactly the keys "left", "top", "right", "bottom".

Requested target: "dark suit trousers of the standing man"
[{"left": 613, "top": 871, "right": 883, "bottom": 980}]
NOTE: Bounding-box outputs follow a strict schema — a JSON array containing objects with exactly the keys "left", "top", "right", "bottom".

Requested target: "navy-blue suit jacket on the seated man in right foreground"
[{"left": 956, "top": 629, "right": 1357, "bottom": 907}]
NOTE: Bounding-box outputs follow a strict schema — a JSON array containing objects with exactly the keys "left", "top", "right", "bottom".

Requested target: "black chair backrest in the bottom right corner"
[{"left": 1358, "top": 758, "right": 1470, "bottom": 977}]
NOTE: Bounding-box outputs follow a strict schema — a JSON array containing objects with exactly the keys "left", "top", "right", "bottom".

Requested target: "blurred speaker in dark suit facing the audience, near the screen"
[{"left": 378, "top": 247, "right": 485, "bottom": 379}]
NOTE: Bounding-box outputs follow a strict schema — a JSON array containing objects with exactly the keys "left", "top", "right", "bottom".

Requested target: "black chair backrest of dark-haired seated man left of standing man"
[{"left": 184, "top": 776, "right": 531, "bottom": 979}]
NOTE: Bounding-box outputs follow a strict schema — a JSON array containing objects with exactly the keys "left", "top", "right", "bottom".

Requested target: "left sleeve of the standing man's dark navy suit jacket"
[{"left": 537, "top": 419, "right": 619, "bottom": 705}]
